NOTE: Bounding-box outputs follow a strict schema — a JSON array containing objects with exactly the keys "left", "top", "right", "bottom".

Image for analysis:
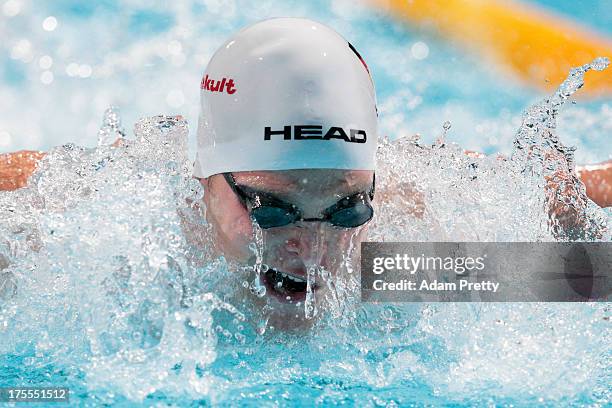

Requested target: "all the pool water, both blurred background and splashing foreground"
[{"left": 0, "top": 0, "right": 612, "bottom": 406}]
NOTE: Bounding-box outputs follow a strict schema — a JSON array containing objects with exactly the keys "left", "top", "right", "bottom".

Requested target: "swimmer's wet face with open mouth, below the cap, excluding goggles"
[{"left": 202, "top": 169, "right": 373, "bottom": 310}]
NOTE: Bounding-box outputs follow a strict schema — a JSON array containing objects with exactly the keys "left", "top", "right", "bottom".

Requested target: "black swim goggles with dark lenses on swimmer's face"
[{"left": 223, "top": 173, "right": 376, "bottom": 229}]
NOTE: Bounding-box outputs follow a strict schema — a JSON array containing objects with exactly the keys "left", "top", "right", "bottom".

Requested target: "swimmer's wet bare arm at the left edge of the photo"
[{"left": 0, "top": 150, "right": 45, "bottom": 191}]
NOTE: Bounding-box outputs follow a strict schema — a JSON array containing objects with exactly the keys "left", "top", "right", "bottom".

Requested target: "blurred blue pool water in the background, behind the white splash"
[{"left": 0, "top": 0, "right": 612, "bottom": 163}]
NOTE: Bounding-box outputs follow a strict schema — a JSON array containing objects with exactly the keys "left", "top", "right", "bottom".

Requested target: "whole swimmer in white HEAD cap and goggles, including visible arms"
[{"left": 0, "top": 18, "right": 612, "bottom": 318}]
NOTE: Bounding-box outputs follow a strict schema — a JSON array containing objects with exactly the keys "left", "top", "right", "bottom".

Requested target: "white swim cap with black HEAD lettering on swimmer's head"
[{"left": 194, "top": 18, "right": 378, "bottom": 177}]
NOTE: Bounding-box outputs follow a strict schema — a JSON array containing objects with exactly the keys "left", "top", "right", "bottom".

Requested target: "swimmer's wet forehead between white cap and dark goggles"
[{"left": 233, "top": 169, "right": 374, "bottom": 194}]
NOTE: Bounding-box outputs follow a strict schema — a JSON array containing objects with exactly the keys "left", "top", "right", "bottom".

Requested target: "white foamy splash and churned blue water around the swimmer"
[{"left": 0, "top": 59, "right": 611, "bottom": 406}]
